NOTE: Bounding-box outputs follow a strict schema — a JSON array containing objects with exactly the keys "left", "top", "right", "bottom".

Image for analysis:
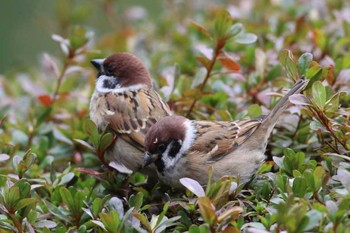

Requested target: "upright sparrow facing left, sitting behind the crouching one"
[{"left": 90, "top": 52, "right": 171, "bottom": 173}]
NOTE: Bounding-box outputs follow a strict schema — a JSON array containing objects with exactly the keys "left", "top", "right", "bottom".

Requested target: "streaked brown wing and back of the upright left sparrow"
[{"left": 105, "top": 88, "right": 171, "bottom": 152}]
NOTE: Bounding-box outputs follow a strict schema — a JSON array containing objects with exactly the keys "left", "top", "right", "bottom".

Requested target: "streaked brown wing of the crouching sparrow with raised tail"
[{"left": 190, "top": 117, "right": 263, "bottom": 161}]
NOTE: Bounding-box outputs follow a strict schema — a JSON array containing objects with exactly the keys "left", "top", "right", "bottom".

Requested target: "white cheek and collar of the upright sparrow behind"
[{"left": 95, "top": 75, "right": 146, "bottom": 94}]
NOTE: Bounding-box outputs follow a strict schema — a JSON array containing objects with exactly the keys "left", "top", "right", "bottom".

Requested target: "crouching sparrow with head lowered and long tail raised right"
[{"left": 144, "top": 79, "right": 307, "bottom": 187}]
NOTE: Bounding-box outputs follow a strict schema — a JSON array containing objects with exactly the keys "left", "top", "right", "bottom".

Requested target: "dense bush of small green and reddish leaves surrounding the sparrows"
[{"left": 0, "top": 1, "right": 350, "bottom": 233}]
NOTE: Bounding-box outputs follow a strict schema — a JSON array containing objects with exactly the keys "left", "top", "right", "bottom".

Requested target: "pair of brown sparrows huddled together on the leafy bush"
[{"left": 90, "top": 53, "right": 306, "bottom": 187}]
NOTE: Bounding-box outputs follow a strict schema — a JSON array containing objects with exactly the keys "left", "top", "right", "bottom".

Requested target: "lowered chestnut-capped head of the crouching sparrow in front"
[{"left": 144, "top": 116, "right": 195, "bottom": 172}]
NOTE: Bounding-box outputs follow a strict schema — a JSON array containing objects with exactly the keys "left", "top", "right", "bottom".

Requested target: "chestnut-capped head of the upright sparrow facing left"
[{"left": 91, "top": 52, "right": 152, "bottom": 92}]
